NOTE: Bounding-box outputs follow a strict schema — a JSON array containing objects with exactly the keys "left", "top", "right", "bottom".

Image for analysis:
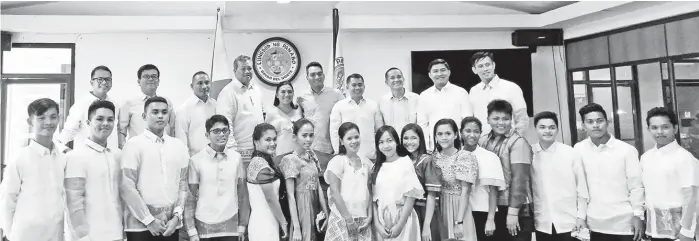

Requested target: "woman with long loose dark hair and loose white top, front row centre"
[{"left": 369, "top": 126, "right": 425, "bottom": 241}]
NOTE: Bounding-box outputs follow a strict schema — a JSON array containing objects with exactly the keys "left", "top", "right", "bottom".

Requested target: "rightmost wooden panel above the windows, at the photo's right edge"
[{"left": 665, "top": 17, "right": 699, "bottom": 56}]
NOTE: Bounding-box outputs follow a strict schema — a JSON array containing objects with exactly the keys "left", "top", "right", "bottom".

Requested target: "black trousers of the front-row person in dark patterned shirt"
[{"left": 494, "top": 204, "right": 532, "bottom": 241}]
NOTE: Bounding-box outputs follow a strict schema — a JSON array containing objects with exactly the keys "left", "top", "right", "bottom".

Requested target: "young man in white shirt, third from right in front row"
[{"left": 531, "top": 111, "right": 590, "bottom": 241}]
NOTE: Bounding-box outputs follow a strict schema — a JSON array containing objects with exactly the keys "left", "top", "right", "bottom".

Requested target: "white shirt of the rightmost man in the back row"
[{"left": 469, "top": 75, "right": 529, "bottom": 136}]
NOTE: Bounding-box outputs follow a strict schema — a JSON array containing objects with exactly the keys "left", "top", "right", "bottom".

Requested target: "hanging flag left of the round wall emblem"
[{"left": 209, "top": 8, "right": 233, "bottom": 99}]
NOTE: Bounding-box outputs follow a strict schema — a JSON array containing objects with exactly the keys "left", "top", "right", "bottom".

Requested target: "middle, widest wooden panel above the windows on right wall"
[{"left": 609, "top": 24, "right": 667, "bottom": 64}]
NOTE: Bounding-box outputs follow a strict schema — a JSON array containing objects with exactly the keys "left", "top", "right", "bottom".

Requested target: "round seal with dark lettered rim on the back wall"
[{"left": 252, "top": 37, "right": 301, "bottom": 85}]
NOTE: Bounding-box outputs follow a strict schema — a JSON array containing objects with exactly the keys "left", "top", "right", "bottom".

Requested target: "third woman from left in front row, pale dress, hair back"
[{"left": 323, "top": 122, "right": 373, "bottom": 241}]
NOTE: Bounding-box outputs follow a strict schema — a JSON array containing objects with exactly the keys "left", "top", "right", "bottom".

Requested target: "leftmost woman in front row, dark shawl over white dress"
[{"left": 247, "top": 123, "right": 288, "bottom": 241}]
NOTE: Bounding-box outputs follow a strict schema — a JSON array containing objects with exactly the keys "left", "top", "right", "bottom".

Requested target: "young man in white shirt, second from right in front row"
[{"left": 574, "top": 103, "right": 645, "bottom": 241}]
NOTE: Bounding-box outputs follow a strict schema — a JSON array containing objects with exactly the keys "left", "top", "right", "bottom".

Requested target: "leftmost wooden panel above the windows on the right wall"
[{"left": 566, "top": 36, "right": 609, "bottom": 69}]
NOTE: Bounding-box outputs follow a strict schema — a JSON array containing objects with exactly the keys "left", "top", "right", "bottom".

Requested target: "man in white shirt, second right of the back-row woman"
[{"left": 330, "top": 74, "right": 383, "bottom": 159}]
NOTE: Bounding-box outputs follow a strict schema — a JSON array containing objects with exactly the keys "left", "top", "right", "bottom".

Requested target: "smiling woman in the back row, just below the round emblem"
[{"left": 265, "top": 81, "right": 303, "bottom": 155}]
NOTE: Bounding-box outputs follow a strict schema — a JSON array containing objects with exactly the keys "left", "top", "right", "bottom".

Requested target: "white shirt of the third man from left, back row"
[{"left": 175, "top": 96, "right": 216, "bottom": 156}]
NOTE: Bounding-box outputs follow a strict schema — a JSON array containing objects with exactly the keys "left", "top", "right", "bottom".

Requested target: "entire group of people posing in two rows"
[{"left": 0, "top": 49, "right": 699, "bottom": 241}]
